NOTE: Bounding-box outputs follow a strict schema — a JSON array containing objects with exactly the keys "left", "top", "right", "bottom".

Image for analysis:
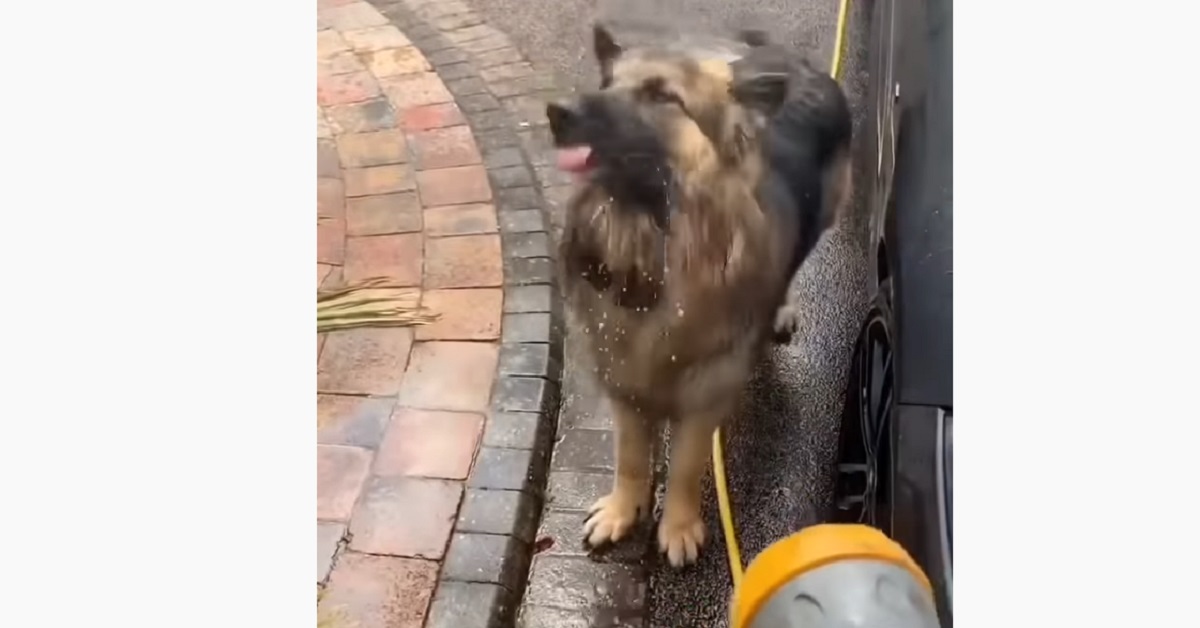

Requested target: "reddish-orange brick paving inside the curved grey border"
[{"left": 317, "top": 0, "right": 504, "bottom": 628}]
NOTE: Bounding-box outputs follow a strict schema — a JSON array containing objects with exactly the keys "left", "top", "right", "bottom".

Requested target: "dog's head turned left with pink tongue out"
[{"left": 546, "top": 25, "right": 787, "bottom": 225}]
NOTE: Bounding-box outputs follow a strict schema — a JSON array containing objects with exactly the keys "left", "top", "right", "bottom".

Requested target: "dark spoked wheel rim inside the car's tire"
[{"left": 838, "top": 304, "right": 894, "bottom": 527}]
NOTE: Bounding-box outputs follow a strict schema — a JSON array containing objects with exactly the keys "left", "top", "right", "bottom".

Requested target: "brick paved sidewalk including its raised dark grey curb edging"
[{"left": 317, "top": 0, "right": 560, "bottom": 628}]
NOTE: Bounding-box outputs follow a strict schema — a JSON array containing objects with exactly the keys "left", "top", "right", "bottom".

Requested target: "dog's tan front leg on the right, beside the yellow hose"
[{"left": 659, "top": 415, "right": 719, "bottom": 568}]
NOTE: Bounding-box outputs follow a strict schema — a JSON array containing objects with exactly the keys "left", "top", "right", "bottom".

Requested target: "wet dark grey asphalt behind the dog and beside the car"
[{"left": 474, "top": 0, "right": 883, "bottom": 628}]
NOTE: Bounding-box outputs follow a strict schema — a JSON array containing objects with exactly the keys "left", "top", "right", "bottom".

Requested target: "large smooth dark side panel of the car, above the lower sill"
[{"left": 883, "top": 0, "right": 954, "bottom": 407}]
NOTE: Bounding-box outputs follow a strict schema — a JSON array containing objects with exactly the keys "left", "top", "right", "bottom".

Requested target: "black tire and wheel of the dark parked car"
[{"left": 832, "top": 277, "right": 895, "bottom": 533}]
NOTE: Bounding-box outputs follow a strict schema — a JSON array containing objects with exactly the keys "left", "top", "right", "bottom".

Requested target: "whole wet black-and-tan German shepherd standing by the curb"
[{"left": 546, "top": 25, "right": 851, "bottom": 567}]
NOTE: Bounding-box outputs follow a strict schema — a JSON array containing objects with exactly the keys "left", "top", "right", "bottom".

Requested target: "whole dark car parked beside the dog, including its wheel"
[{"left": 834, "top": 0, "right": 954, "bottom": 628}]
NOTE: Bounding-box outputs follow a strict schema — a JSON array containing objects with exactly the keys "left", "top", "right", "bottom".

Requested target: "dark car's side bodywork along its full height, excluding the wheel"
[{"left": 864, "top": 0, "right": 954, "bottom": 628}]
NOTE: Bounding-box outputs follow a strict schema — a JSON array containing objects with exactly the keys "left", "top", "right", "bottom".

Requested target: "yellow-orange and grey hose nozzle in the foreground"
[{"left": 731, "top": 524, "right": 938, "bottom": 628}]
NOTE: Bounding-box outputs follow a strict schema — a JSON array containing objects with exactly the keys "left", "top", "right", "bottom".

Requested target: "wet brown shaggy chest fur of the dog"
[{"left": 559, "top": 190, "right": 786, "bottom": 414}]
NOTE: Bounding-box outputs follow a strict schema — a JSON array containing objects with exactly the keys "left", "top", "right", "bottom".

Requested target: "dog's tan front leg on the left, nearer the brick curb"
[{"left": 583, "top": 400, "right": 654, "bottom": 548}]
